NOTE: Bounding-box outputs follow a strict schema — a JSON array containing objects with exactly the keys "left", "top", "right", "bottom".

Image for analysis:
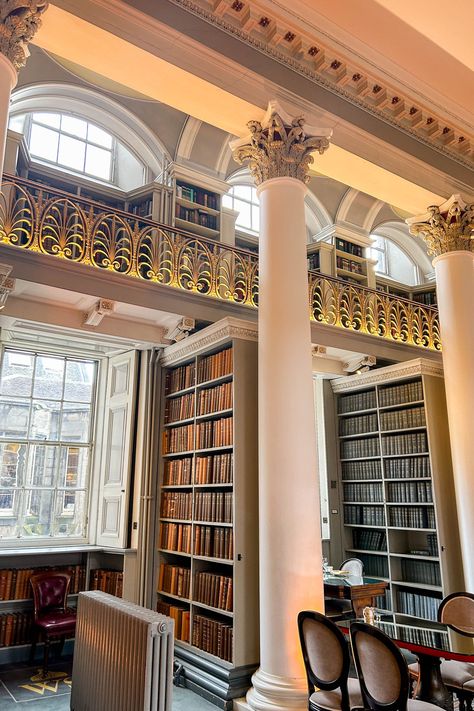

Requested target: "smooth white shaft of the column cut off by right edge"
[{"left": 433, "top": 251, "right": 474, "bottom": 592}]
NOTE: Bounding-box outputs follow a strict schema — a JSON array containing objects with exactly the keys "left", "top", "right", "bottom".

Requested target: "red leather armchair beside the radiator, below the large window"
[{"left": 30, "top": 571, "right": 76, "bottom": 676}]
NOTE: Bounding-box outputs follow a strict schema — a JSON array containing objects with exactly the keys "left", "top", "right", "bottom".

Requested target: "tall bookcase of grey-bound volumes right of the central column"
[{"left": 332, "top": 359, "right": 463, "bottom": 624}]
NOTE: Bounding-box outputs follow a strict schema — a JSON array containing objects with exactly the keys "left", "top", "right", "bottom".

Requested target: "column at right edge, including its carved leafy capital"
[{"left": 407, "top": 195, "right": 474, "bottom": 592}]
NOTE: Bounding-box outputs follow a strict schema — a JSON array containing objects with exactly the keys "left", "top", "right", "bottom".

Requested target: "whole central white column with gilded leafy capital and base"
[{"left": 231, "top": 103, "right": 331, "bottom": 711}]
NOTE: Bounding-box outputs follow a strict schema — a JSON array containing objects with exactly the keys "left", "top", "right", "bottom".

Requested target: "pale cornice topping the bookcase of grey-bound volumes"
[{"left": 331, "top": 358, "right": 443, "bottom": 393}]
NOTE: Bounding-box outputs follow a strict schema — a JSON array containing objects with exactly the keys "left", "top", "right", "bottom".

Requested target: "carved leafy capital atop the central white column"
[{"left": 230, "top": 101, "right": 332, "bottom": 185}]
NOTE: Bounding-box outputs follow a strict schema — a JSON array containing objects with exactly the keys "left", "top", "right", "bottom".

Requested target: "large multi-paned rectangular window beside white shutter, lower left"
[{"left": 0, "top": 349, "right": 98, "bottom": 540}]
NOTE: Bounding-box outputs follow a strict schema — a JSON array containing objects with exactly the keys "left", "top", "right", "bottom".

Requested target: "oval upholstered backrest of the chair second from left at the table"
[{"left": 350, "top": 622, "right": 410, "bottom": 711}]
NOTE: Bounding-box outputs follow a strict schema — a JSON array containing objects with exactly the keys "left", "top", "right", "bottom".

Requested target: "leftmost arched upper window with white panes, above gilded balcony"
[{"left": 28, "top": 112, "right": 114, "bottom": 182}]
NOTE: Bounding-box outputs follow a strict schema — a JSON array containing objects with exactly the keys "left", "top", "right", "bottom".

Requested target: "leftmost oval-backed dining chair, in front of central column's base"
[{"left": 298, "top": 610, "right": 362, "bottom": 711}]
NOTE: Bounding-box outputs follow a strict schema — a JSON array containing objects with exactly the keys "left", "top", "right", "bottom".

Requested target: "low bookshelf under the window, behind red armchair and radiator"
[{"left": 0, "top": 546, "right": 133, "bottom": 664}]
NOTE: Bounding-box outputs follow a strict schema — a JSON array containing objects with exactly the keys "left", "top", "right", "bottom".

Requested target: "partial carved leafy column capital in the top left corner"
[{"left": 0, "top": 0, "right": 49, "bottom": 71}]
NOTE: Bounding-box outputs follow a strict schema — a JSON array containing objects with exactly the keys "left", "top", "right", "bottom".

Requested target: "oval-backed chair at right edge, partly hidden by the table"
[{"left": 409, "top": 592, "right": 474, "bottom": 711}]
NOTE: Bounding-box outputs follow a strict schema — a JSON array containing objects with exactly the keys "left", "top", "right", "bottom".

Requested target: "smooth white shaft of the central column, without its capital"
[{"left": 258, "top": 178, "right": 324, "bottom": 680}]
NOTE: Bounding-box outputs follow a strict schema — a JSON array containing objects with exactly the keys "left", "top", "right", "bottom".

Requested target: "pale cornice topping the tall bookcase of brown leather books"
[{"left": 160, "top": 317, "right": 258, "bottom": 366}]
